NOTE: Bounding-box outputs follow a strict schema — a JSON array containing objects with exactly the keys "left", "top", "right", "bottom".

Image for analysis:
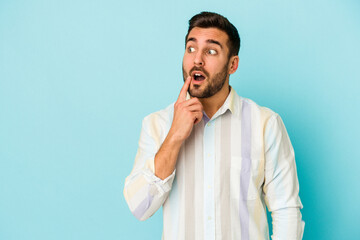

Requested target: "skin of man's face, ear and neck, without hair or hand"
[{"left": 183, "top": 27, "right": 239, "bottom": 118}]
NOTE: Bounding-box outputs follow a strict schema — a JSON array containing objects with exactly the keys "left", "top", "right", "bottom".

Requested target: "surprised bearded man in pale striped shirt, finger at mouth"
[{"left": 124, "top": 12, "right": 304, "bottom": 240}]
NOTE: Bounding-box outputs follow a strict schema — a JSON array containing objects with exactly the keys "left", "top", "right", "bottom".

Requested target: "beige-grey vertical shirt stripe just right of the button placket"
[{"left": 219, "top": 111, "right": 231, "bottom": 239}]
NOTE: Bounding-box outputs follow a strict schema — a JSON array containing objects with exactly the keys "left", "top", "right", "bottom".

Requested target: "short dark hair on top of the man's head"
[{"left": 185, "top": 12, "right": 240, "bottom": 57}]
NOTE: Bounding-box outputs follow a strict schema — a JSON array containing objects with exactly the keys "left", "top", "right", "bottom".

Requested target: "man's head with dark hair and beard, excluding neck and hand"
[{"left": 183, "top": 12, "right": 240, "bottom": 98}]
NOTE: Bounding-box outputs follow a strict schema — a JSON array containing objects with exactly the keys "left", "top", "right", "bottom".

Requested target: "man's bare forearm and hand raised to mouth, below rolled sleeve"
[{"left": 154, "top": 77, "right": 203, "bottom": 179}]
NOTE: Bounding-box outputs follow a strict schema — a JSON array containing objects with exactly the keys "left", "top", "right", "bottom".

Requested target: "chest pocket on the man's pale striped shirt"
[{"left": 231, "top": 157, "right": 264, "bottom": 201}]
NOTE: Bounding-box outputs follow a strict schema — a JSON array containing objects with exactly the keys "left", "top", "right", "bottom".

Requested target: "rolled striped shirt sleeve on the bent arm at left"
[{"left": 124, "top": 114, "right": 175, "bottom": 221}]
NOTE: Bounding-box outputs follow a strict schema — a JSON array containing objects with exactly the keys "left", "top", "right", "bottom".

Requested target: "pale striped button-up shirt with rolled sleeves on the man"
[{"left": 124, "top": 89, "right": 304, "bottom": 240}]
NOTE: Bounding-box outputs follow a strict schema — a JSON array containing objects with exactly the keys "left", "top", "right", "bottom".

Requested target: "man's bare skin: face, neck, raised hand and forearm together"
[{"left": 155, "top": 27, "right": 239, "bottom": 179}]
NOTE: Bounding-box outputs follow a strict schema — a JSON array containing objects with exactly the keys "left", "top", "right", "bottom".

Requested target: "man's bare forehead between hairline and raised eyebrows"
[{"left": 186, "top": 27, "right": 228, "bottom": 45}]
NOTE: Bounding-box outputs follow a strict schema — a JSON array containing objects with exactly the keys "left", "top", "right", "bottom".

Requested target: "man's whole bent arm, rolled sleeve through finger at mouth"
[{"left": 124, "top": 78, "right": 202, "bottom": 220}]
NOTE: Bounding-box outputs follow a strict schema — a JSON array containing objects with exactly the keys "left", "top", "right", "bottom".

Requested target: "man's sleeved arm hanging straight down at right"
[{"left": 263, "top": 114, "right": 305, "bottom": 240}]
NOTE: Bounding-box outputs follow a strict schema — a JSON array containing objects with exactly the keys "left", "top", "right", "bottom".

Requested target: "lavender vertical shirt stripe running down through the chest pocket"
[{"left": 239, "top": 101, "right": 251, "bottom": 240}]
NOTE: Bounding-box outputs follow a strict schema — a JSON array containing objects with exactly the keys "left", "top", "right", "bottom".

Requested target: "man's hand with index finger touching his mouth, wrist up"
[{"left": 169, "top": 76, "right": 203, "bottom": 142}]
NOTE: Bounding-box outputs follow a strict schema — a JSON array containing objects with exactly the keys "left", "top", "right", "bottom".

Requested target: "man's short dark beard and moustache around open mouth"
[{"left": 183, "top": 63, "right": 229, "bottom": 98}]
